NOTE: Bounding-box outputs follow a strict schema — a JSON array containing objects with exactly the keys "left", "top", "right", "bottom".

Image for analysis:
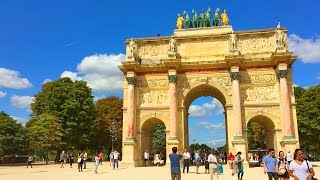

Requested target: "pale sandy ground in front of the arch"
[{"left": 0, "top": 162, "right": 320, "bottom": 180}]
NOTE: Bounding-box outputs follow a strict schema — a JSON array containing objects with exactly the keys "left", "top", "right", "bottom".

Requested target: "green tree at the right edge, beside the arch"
[{"left": 294, "top": 85, "right": 320, "bottom": 158}]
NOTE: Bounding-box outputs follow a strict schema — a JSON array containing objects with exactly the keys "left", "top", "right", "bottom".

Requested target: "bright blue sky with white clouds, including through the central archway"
[{"left": 0, "top": 0, "right": 320, "bottom": 148}]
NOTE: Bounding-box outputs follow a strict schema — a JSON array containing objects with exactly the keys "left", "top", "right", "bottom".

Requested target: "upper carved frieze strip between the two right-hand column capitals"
[{"left": 241, "top": 74, "right": 277, "bottom": 83}]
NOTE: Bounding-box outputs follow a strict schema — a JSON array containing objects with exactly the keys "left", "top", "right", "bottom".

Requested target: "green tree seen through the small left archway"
[{"left": 152, "top": 123, "right": 166, "bottom": 153}]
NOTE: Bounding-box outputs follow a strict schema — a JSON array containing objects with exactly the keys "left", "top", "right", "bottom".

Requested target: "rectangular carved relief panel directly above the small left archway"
[{"left": 138, "top": 90, "right": 169, "bottom": 105}]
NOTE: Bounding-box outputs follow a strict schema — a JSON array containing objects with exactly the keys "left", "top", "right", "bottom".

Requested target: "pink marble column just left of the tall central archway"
[{"left": 168, "top": 75, "right": 177, "bottom": 139}]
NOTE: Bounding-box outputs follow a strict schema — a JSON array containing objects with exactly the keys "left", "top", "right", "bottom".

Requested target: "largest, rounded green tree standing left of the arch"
[{"left": 30, "top": 78, "right": 95, "bottom": 149}]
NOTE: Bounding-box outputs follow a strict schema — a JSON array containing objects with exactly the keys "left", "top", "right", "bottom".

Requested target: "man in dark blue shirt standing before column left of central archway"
[{"left": 169, "top": 147, "right": 182, "bottom": 180}]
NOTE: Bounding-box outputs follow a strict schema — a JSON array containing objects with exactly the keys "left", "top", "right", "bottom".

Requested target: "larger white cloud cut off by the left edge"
[{"left": 0, "top": 68, "right": 32, "bottom": 89}]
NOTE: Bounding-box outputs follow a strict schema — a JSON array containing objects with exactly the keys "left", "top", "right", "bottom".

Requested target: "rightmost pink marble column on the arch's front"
[{"left": 278, "top": 70, "right": 293, "bottom": 137}]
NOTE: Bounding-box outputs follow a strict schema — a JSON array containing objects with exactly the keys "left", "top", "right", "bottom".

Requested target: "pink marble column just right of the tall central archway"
[{"left": 230, "top": 72, "right": 242, "bottom": 138}]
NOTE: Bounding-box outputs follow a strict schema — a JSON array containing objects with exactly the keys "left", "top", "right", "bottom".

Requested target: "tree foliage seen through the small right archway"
[{"left": 247, "top": 122, "right": 266, "bottom": 149}]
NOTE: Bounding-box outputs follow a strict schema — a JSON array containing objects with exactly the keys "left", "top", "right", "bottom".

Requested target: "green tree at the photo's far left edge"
[{"left": 0, "top": 111, "right": 28, "bottom": 157}]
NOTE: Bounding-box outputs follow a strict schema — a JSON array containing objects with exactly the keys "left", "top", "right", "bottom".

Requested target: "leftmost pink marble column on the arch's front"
[{"left": 127, "top": 77, "right": 134, "bottom": 138}]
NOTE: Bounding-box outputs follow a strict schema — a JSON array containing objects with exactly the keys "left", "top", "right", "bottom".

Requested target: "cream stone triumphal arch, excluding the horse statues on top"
[{"left": 119, "top": 17, "right": 299, "bottom": 166}]
